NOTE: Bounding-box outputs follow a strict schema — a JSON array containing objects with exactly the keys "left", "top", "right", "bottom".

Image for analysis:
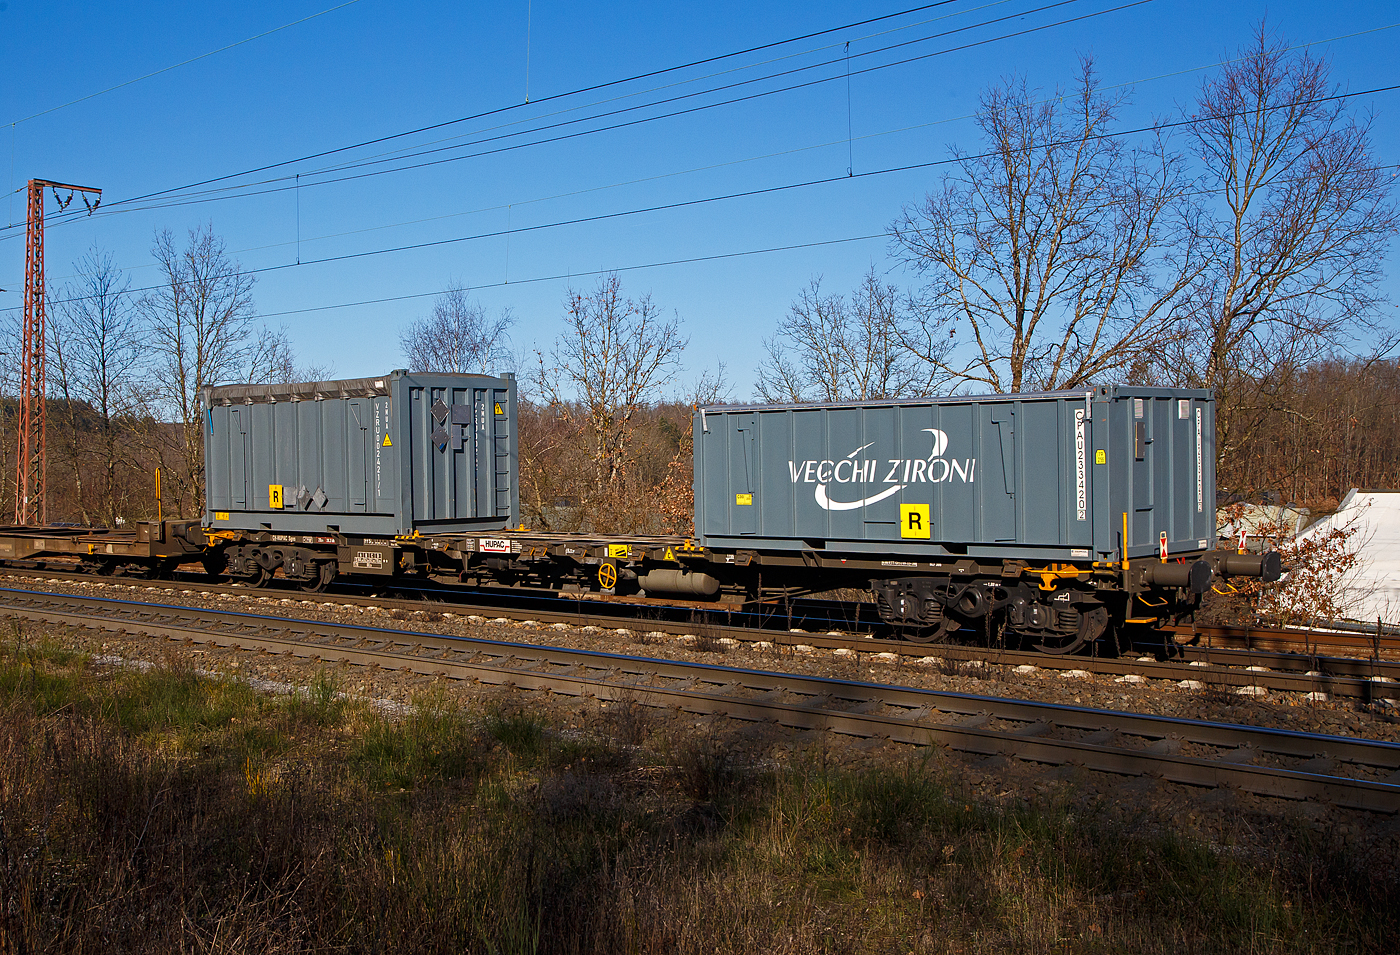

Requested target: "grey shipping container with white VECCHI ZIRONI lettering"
[{"left": 693, "top": 385, "right": 1215, "bottom": 560}]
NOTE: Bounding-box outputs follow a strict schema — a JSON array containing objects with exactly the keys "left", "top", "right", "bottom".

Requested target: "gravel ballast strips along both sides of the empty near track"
[{"left": 15, "top": 578, "right": 1400, "bottom": 867}]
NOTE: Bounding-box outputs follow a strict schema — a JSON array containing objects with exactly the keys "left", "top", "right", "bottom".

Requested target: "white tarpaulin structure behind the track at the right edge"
[{"left": 1298, "top": 489, "right": 1400, "bottom": 625}]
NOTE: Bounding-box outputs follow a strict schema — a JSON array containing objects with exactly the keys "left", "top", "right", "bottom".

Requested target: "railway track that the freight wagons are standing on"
[{"left": 0, "top": 570, "right": 1400, "bottom": 703}]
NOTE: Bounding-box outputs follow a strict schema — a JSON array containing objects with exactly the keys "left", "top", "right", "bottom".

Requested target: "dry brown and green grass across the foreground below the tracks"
[{"left": 0, "top": 632, "right": 1400, "bottom": 954}]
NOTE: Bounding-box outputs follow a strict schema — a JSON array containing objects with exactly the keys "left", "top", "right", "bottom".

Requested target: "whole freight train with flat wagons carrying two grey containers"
[{"left": 0, "top": 371, "right": 1281, "bottom": 653}]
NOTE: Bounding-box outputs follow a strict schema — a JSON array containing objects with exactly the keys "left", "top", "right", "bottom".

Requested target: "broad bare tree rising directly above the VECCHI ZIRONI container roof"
[{"left": 890, "top": 59, "right": 1198, "bottom": 392}]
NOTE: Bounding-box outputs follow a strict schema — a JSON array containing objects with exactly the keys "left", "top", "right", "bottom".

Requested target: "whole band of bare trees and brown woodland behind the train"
[{"left": 13, "top": 24, "right": 1400, "bottom": 534}]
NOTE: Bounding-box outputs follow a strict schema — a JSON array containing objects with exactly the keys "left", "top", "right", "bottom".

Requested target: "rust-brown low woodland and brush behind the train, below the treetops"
[{"left": 10, "top": 350, "right": 1400, "bottom": 534}]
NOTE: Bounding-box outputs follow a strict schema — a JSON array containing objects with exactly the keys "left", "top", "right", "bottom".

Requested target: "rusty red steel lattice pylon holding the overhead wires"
[{"left": 14, "top": 179, "right": 102, "bottom": 524}]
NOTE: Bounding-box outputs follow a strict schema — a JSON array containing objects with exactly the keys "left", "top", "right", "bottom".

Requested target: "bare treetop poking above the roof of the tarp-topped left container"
[{"left": 399, "top": 284, "right": 515, "bottom": 374}]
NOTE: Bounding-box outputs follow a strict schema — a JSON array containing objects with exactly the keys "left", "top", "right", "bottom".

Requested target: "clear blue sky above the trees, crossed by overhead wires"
[{"left": 0, "top": 0, "right": 1400, "bottom": 398}]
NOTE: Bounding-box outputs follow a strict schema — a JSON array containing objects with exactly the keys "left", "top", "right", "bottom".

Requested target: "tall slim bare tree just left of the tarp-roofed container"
[{"left": 140, "top": 224, "right": 258, "bottom": 514}]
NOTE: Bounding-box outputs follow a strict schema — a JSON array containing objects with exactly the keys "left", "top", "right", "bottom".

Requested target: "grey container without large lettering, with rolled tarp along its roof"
[{"left": 202, "top": 371, "right": 519, "bottom": 538}]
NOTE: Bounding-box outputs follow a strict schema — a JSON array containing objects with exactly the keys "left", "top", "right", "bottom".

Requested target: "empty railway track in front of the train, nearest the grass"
[{"left": 0, "top": 590, "right": 1400, "bottom": 814}]
